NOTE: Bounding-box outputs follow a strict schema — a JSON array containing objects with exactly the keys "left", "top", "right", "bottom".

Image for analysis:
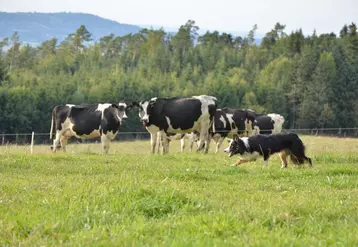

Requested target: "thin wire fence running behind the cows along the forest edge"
[{"left": 0, "top": 127, "right": 358, "bottom": 145}]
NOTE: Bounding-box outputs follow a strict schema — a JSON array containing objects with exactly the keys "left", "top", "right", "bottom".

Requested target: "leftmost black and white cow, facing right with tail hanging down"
[{"left": 50, "top": 103, "right": 130, "bottom": 153}]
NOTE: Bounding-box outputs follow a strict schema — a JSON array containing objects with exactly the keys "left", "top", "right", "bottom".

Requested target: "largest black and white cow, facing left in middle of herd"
[{"left": 133, "top": 95, "right": 216, "bottom": 153}]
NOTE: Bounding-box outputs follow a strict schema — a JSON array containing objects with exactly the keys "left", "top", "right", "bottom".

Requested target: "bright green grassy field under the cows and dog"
[{"left": 0, "top": 137, "right": 358, "bottom": 246}]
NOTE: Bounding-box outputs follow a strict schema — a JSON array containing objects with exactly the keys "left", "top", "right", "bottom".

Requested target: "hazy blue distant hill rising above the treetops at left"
[{"left": 0, "top": 12, "right": 141, "bottom": 45}]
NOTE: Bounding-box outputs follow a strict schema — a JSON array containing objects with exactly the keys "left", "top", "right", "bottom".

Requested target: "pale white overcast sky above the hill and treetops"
[{"left": 0, "top": 0, "right": 358, "bottom": 34}]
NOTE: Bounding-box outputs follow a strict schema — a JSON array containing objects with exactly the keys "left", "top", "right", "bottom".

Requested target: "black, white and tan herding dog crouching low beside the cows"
[{"left": 224, "top": 133, "right": 312, "bottom": 168}]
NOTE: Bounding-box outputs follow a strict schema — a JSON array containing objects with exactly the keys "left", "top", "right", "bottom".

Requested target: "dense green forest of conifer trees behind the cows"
[{"left": 0, "top": 20, "right": 358, "bottom": 133}]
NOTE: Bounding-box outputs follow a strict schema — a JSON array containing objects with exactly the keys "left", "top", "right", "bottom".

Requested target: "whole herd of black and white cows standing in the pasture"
[{"left": 50, "top": 95, "right": 284, "bottom": 153}]
